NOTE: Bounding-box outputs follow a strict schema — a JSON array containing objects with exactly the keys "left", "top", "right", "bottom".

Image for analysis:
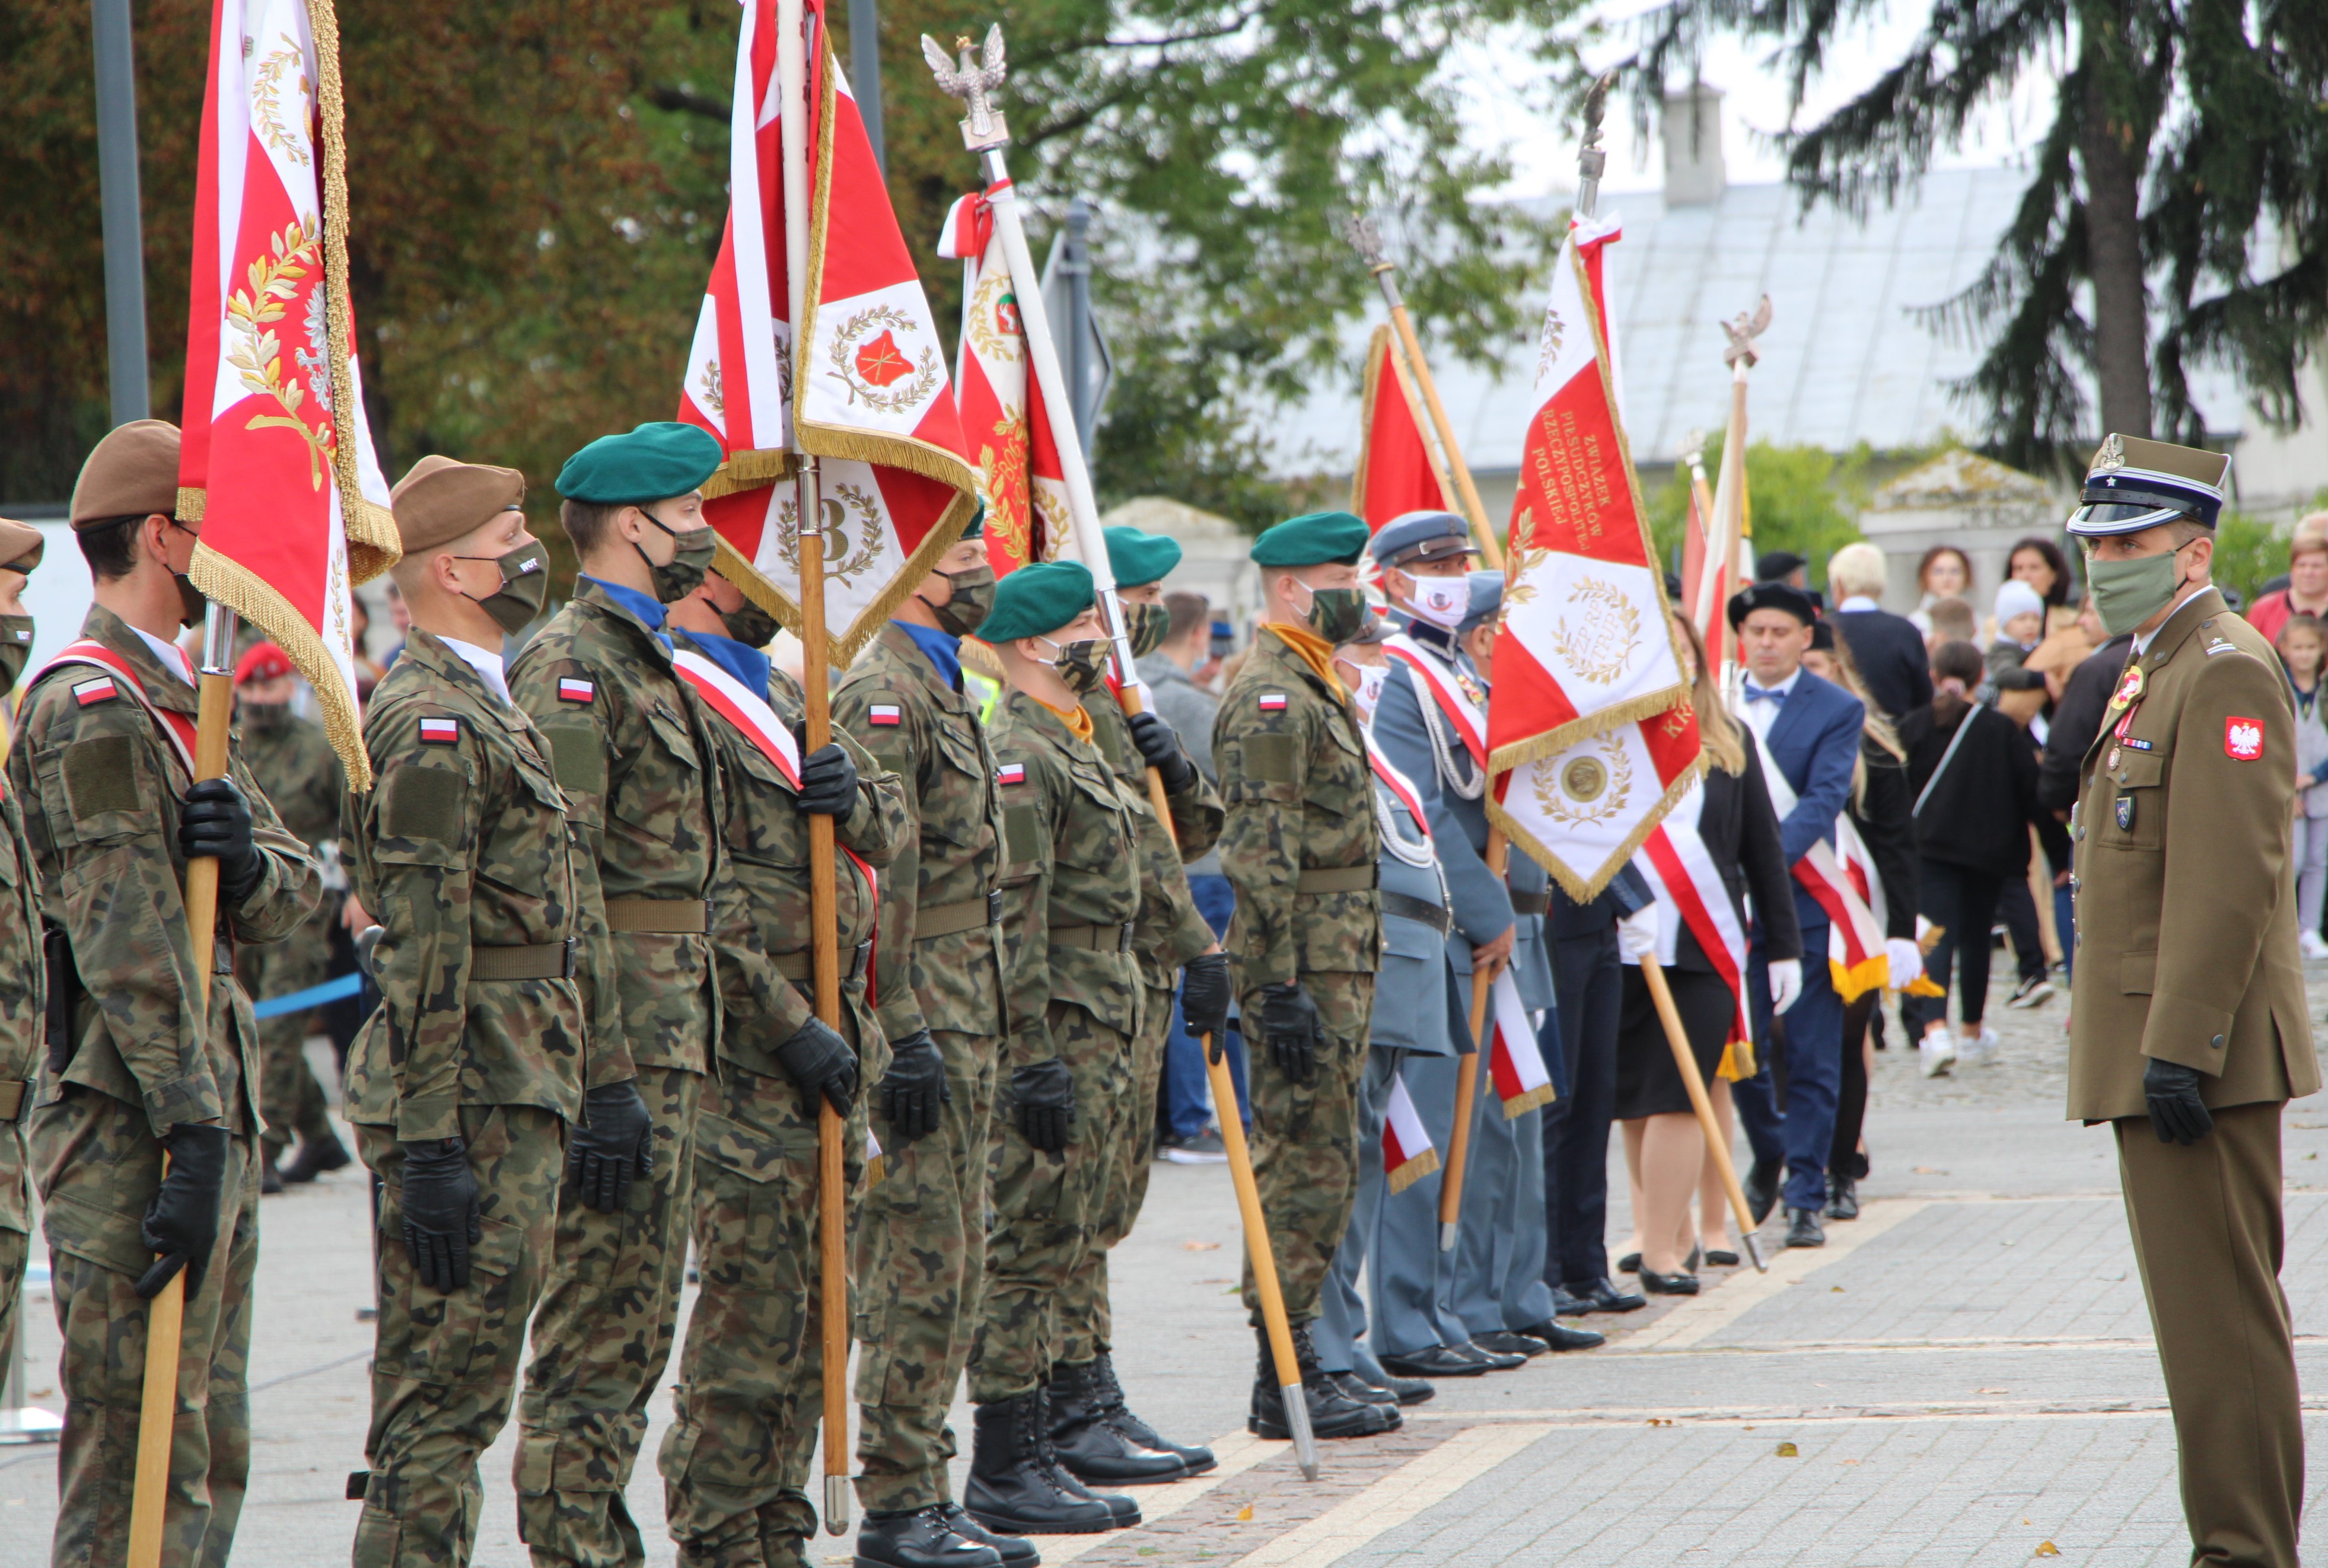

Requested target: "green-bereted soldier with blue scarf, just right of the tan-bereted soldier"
[{"left": 510, "top": 423, "right": 724, "bottom": 1568}]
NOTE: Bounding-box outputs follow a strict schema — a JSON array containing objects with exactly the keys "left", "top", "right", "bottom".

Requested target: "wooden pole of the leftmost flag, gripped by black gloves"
[{"left": 128, "top": 603, "right": 235, "bottom": 1568}]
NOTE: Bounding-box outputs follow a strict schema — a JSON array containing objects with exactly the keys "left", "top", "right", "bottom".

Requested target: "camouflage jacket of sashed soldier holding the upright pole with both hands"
[{"left": 673, "top": 633, "right": 913, "bottom": 1082}]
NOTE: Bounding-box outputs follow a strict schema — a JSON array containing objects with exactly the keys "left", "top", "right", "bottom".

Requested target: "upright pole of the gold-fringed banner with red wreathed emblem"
[{"left": 775, "top": 0, "right": 850, "bottom": 1535}]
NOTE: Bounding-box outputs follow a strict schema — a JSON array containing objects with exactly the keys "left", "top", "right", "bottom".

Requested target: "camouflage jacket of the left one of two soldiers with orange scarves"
[{"left": 994, "top": 691, "right": 1141, "bottom": 1068}]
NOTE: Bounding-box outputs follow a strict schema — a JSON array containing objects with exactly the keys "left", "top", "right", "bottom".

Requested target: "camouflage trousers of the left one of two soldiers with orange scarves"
[{"left": 969, "top": 1003, "right": 1132, "bottom": 1405}]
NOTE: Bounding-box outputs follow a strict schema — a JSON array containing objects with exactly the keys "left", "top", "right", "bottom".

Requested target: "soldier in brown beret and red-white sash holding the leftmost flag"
[{"left": 7, "top": 419, "right": 319, "bottom": 1568}]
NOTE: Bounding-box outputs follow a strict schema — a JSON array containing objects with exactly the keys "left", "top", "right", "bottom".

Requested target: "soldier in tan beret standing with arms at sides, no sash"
[{"left": 345, "top": 456, "right": 647, "bottom": 1568}]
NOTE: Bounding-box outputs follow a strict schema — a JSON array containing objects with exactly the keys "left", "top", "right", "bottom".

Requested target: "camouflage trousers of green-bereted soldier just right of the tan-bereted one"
[{"left": 517, "top": 1066, "right": 703, "bottom": 1568}]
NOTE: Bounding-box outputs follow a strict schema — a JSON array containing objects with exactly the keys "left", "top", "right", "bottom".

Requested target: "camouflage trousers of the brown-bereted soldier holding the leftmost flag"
[{"left": 33, "top": 1084, "right": 259, "bottom": 1568}]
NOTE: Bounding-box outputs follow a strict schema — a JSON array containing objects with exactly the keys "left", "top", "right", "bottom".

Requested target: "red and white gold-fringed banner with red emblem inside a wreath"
[{"left": 680, "top": 0, "right": 978, "bottom": 665}]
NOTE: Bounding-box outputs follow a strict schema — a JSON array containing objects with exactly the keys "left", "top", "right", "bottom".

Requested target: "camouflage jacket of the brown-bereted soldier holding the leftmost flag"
[{"left": 7, "top": 605, "right": 321, "bottom": 1135}]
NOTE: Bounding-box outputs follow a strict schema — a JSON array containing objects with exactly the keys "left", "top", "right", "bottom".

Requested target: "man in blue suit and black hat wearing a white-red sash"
[{"left": 1730, "top": 582, "right": 1867, "bottom": 1247}]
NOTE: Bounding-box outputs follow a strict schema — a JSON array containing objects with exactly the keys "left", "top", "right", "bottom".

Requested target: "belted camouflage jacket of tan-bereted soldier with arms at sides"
[{"left": 345, "top": 628, "right": 633, "bottom": 1142}]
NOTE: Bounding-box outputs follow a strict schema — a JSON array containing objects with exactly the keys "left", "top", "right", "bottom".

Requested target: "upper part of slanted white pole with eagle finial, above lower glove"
[{"left": 922, "top": 23, "right": 1171, "bottom": 833}]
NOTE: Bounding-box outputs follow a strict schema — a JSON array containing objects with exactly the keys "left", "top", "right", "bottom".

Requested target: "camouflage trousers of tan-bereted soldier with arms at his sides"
[{"left": 354, "top": 1105, "right": 566, "bottom": 1568}]
